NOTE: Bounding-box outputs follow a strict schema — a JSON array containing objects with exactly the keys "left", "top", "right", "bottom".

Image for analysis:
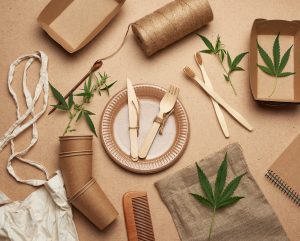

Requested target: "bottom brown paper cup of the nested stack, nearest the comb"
[{"left": 71, "top": 179, "right": 118, "bottom": 230}]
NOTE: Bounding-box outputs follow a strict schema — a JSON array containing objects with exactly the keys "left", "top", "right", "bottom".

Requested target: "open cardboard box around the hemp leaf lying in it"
[{"left": 249, "top": 19, "right": 300, "bottom": 105}]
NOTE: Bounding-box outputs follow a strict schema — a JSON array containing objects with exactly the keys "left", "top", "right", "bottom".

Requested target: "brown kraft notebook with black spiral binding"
[{"left": 265, "top": 135, "right": 300, "bottom": 206}]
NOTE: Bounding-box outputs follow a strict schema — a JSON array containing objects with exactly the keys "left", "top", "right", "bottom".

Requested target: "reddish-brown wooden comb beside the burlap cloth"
[{"left": 123, "top": 192, "right": 155, "bottom": 241}]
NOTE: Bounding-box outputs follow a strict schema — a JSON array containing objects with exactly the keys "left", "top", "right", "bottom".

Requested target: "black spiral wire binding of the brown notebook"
[{"left": 265, "top": 170, "right": 300, "bottom": 206}]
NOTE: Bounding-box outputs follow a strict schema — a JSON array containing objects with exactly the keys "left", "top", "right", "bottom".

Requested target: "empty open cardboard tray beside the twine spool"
[{"left": 37, "top": 0, "right": 125, "bottom": 53}]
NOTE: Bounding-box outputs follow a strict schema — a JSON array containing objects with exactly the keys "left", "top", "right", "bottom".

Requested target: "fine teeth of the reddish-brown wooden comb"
[{"left": 132, "top": 196, "right": 155, "bottom": 241}]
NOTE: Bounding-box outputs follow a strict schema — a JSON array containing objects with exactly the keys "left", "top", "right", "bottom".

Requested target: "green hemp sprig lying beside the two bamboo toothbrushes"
[{"left": 197, "top": 33, "right": 248, "bottom": 95}]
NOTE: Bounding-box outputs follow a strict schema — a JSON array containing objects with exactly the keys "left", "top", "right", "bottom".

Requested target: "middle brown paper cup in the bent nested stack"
[{"left": 59, "top": 151, "right": 92, "bottom": 197}]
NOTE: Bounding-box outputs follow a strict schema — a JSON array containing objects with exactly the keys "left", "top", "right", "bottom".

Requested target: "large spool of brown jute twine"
[{"left": 132, "top": 0, "right": 213, "bottom": 56}]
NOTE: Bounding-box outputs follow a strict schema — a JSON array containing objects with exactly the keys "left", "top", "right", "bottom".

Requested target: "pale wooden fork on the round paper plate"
[{"left": 139, "top": 85, "right": 179, "bottom": 158}]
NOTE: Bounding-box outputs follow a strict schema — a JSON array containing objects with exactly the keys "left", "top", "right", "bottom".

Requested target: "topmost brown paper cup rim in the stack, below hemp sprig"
[{"left": 59, "top": 135, "right": 93, "bottom": 153}]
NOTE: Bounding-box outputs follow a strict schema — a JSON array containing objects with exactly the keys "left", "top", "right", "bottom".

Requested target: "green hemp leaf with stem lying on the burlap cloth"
[{"left": 190, "top": 153, "right": 246, "bottom": 240}]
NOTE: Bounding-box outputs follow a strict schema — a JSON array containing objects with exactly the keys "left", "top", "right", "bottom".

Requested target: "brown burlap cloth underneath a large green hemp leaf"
[{"left": 155, "top": 144, "right": 289, "bottom": 241}]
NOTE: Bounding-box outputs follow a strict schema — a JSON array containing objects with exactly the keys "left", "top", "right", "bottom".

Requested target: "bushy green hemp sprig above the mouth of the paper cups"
[{"left": 50, "top": 73, "right": 117, "bottom": 136}]
